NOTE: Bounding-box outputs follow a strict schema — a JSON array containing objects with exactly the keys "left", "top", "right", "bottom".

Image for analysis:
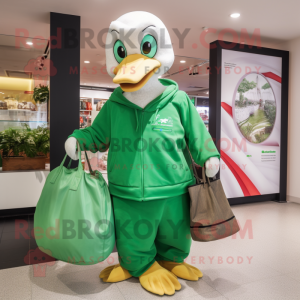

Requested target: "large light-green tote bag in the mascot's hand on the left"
[{"left": 34, "top": 147, "right": 115, "bottom": 265}]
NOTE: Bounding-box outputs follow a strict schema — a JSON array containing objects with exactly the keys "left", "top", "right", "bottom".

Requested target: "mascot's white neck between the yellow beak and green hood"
[{"left": 123, "top": 76, "right": 166, "bottom": 108}]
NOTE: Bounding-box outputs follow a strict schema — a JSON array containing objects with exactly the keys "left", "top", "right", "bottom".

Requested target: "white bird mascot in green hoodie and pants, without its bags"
[{"left": 65, "top": 11, "right": 220, "bottom": 295}]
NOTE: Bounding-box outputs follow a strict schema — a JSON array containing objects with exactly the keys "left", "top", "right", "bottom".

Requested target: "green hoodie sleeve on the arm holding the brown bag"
[{"left": 180, "top": 92, "right": 220, "bottom": 167}]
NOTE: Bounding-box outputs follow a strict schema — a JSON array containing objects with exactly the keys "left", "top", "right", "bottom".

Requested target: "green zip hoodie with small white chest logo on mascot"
[{"left": 70, "top": 79, "right": 220, "bottom": 201}]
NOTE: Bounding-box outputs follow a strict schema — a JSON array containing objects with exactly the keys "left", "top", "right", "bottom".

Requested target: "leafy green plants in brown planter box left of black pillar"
[{"left": 0, "top": 124, "right": 50, "bottom": 171}]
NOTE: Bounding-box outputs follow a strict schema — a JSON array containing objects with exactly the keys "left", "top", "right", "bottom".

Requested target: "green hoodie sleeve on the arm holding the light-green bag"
[{"left": 69, "top": 101, "right": 111, "bottom": 153}]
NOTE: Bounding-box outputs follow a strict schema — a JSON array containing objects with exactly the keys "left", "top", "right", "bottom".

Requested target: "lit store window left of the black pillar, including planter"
[{"left": 0, "top": 35, "right": 51, "bottom": 172}]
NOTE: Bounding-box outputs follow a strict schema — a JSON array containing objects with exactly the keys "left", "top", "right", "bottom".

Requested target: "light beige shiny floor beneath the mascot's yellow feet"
[{"left": 0, "top": 202, "right": 300, "bottom": 300}]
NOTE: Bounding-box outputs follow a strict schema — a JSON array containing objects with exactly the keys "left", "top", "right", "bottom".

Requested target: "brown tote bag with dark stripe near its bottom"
[{"left": 188, "top": 159, "right": 240, "bottom": 242}]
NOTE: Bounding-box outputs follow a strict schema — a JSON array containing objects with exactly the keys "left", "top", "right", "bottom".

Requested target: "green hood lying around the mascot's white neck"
[{"left": 109, "top": 79, "right": 178, "bottom": 112}]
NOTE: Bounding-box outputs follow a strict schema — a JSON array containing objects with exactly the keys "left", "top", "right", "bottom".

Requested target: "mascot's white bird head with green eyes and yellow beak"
[{"left": 105, "top": 11, "right": 174, "bottom": 92}]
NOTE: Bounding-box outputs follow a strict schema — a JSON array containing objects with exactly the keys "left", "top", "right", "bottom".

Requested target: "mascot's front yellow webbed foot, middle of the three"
[{"left": 139, "top": 262, "right": 181, "bottom": 295}]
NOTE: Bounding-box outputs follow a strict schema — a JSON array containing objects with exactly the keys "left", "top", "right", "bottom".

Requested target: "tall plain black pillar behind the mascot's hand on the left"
[{"left": 50, "top": 13, "right": 80, "bottom": 170}]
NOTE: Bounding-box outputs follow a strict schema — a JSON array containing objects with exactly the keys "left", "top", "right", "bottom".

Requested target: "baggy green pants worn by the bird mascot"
[{"left": 113, "top": 194, "right": 191, "bottom": 277}]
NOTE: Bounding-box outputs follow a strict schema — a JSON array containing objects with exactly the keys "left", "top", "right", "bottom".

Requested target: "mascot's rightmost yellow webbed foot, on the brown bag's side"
[{"left": 158, "top": 260, "right": 203, "bottom": 281}]
